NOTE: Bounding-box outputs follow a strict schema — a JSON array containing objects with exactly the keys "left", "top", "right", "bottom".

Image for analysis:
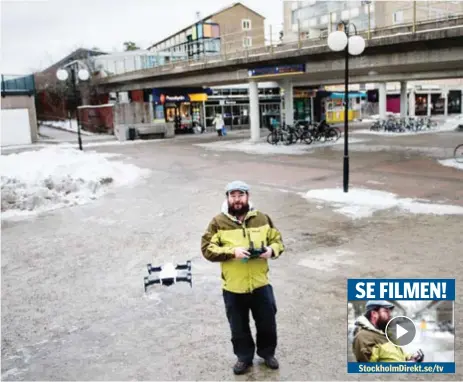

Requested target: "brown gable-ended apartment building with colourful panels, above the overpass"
[{"left": 148, "top": 3, "right": 265, "bottom": 59}]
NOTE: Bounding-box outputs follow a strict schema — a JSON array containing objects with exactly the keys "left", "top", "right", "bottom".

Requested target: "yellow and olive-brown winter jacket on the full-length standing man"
[{"left": 201, "top": 204, "right": 284, "bottom": 293}]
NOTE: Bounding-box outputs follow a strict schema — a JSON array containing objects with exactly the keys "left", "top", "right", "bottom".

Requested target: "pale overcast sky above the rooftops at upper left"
[{"left": 0, "top": 0, "right": 283, "bottom": 74}]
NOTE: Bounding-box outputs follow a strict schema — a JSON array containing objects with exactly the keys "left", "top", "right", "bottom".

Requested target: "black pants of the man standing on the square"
[{"left": 223, "top": 285, "right": 277, "bottom": 362}]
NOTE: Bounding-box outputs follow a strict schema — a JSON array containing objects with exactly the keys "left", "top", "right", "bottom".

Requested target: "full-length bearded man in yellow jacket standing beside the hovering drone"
[{"left": 201, "top": 181, "right": 284, "bottom": 374}]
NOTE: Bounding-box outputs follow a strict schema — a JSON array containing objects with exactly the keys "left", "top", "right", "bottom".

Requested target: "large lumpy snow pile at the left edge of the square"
[{"left": 0, "top": 146, "right": 150, "bottom": 218}]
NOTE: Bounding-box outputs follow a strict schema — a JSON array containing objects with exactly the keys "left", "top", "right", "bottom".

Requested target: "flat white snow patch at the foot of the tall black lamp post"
[{"left": 302, "top": 188, "right": 463, "bottom": 219}]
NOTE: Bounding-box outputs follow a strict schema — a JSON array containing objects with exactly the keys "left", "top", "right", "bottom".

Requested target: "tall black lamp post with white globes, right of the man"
[{"left": 328, "top": 21, "right": 365, "bottom": 192}]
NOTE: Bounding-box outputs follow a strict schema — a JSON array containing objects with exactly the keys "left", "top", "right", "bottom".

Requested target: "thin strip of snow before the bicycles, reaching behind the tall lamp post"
[{"left": 195, "top": 139, "right": 364, "bottom": 155}]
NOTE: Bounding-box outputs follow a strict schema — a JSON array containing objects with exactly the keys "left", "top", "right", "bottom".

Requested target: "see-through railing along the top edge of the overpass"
[{"left": 96, "top": 12, "right": 463, "bottom": 77}]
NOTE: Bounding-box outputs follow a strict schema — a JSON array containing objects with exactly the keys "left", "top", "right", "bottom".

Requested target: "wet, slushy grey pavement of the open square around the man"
[{"left": 2, "top": 127, "right": 463, "bottom": 380}]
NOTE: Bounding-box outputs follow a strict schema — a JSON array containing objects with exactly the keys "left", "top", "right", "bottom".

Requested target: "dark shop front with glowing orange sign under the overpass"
[{"left": 152, "top": 88, "right": 208, "bottom": 133}]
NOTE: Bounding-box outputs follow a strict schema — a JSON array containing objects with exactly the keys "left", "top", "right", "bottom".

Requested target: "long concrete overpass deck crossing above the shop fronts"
[{"left": 94, "top": 16, "right": 463, "bottom": 92}]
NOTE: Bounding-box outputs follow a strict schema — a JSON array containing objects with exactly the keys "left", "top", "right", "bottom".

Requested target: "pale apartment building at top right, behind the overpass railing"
[{"left": 283, "top": 0, "right": 463, "bottom": 40}]
